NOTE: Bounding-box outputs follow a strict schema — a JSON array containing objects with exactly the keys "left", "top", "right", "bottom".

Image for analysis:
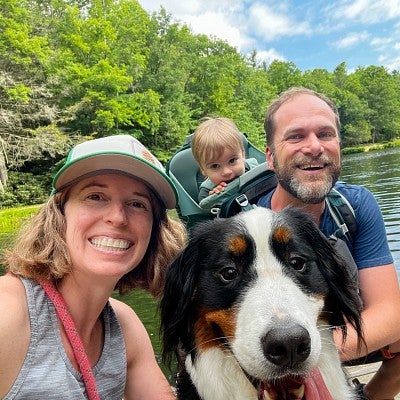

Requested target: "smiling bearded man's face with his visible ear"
[{"left": 267, "top": 94, "right": 341, "bottom": 204}]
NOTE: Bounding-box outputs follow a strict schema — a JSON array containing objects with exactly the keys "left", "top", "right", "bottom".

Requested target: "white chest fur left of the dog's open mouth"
[{"left": 185, "top": 348, "right": 257, "bottom": 400}]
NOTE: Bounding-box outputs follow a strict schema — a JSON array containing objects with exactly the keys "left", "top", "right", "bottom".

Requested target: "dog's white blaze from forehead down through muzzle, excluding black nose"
[{"left": 232, "top": 208, "right": 323, "bottom": 380}]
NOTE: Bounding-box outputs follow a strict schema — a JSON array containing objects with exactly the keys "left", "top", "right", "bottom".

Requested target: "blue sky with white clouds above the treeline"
[{"left": 139, "top": 0, "right": 400, "bottom": 72}]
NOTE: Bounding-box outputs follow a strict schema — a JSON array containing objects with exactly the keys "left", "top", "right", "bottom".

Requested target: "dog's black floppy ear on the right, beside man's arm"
[{"left": 314, "top": 233, "right": 363, "bottom": 339}]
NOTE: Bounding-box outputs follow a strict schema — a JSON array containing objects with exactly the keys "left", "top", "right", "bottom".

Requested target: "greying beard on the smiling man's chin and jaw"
[{"left": 274, "top": 159, "right": 340, "bottom": 204}]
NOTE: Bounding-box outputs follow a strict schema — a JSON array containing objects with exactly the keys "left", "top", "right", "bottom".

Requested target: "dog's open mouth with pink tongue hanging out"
[{"left": 258, "top": 368, "right": 333, "bottom": 400}]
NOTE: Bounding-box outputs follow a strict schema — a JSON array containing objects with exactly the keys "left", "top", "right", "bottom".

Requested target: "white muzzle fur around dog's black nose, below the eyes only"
[{"left": 232, "top": 273, "right": 323, "bottom": 380}]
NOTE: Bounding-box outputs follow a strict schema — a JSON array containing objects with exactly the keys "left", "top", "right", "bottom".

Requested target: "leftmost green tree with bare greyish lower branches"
[{"left": 0, "top": 0, "right": 65, "bottom": 175}]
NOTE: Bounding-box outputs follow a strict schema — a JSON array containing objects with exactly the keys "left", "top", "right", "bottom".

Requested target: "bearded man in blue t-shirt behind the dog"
[{"left": 258, "top": 88, "right": 400, "bottom": 400}]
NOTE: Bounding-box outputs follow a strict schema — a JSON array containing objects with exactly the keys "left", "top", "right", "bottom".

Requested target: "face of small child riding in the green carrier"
[{"left": 202, "top": 149, "right": 245, "bottom": 185}]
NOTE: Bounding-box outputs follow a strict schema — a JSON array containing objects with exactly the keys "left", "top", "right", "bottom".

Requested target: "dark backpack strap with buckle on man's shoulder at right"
[{"left": 325, "top": 189, "right": 357, "bottom": 243}]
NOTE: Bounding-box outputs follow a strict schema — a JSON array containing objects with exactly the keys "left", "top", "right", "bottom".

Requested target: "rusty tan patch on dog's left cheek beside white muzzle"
[{"left": 194, "top": 308, "right": 236, "bottom": 351}]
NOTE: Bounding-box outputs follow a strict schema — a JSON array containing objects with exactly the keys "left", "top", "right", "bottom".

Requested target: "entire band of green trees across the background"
[{"left": 0, "top": 0, "right": 400, "bottom": 198}]
